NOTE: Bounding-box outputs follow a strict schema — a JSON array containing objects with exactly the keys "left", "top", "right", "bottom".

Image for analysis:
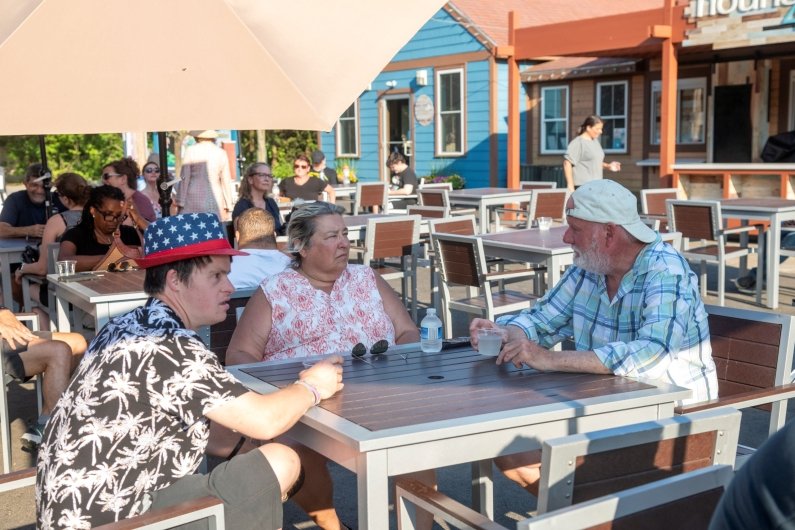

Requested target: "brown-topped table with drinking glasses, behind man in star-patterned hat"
[{"left": 47, "top": 270, "right": 148, "bottom": 332}]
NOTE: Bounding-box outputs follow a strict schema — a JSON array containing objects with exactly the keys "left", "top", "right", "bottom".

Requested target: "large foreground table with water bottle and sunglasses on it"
[{"left": 227, "top": 343, "right": 690, "bottom": 530}]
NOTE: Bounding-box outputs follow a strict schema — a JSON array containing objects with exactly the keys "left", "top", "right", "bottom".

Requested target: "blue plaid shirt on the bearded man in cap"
[{"left": 497, "top": 237, "right": 718, "bottom": 404}]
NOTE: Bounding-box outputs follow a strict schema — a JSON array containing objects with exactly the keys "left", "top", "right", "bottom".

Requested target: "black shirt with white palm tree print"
[{"left": 36, "top": 298, "right": 247, "bottom": 529}]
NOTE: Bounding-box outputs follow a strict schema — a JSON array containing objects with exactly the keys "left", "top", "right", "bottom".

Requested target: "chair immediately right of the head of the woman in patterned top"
[{"left": 363, "top": 215, "right": 421, "bottom": 321}]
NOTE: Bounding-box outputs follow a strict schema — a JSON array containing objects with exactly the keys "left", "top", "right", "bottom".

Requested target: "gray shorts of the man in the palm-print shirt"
[{"left": 149, "top": 451, "right": 282, "bottom": 530}]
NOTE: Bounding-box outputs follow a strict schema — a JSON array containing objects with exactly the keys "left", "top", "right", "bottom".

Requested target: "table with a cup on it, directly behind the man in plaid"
[{"left": 478, "top": 226, "right": 574, "bottom": 288}]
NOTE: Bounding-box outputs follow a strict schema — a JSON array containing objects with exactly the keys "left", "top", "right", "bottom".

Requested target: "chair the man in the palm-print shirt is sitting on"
[{"left": 0, "top": 467, "right": 226, "bottom": 530}]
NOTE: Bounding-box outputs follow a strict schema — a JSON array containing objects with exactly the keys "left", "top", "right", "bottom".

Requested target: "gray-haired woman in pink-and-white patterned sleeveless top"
[{"left": 227, "top": 202, "right": 433, "bottom": 530}]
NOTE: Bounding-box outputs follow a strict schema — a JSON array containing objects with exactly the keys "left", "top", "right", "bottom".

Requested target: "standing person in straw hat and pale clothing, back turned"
[{"left": 177, "top": 129, "right": 235, "bottom": 221}]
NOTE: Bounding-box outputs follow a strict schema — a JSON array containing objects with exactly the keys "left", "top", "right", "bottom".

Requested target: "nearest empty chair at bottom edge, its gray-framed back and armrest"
[{"left": 395, "top": 465, "right": 734, "bottom": 530}]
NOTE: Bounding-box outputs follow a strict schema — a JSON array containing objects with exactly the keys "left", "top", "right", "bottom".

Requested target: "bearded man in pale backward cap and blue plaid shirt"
[{"left": 470, "top": 180, "right": 718, "bottom": 495}]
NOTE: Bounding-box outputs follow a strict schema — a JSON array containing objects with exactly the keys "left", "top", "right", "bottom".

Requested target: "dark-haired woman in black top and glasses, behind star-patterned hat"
[{"left": 58, "top": 185, "right": 141, "bottom": 271}]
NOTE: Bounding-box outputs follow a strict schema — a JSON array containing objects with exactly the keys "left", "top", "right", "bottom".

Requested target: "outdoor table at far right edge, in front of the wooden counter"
[{"left": 720, "top": 198, "right": 795, "bottom": 309}]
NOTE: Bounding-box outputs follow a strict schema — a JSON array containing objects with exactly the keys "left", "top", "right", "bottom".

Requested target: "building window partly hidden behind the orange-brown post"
[{"left": 651, "top": 77, "right": 707, "bottom": 145}]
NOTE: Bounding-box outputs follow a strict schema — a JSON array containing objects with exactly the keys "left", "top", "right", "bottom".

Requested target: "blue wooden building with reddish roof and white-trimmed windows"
[{"left": 319, "top": 0, "right": 534, "bottom": 188}]
